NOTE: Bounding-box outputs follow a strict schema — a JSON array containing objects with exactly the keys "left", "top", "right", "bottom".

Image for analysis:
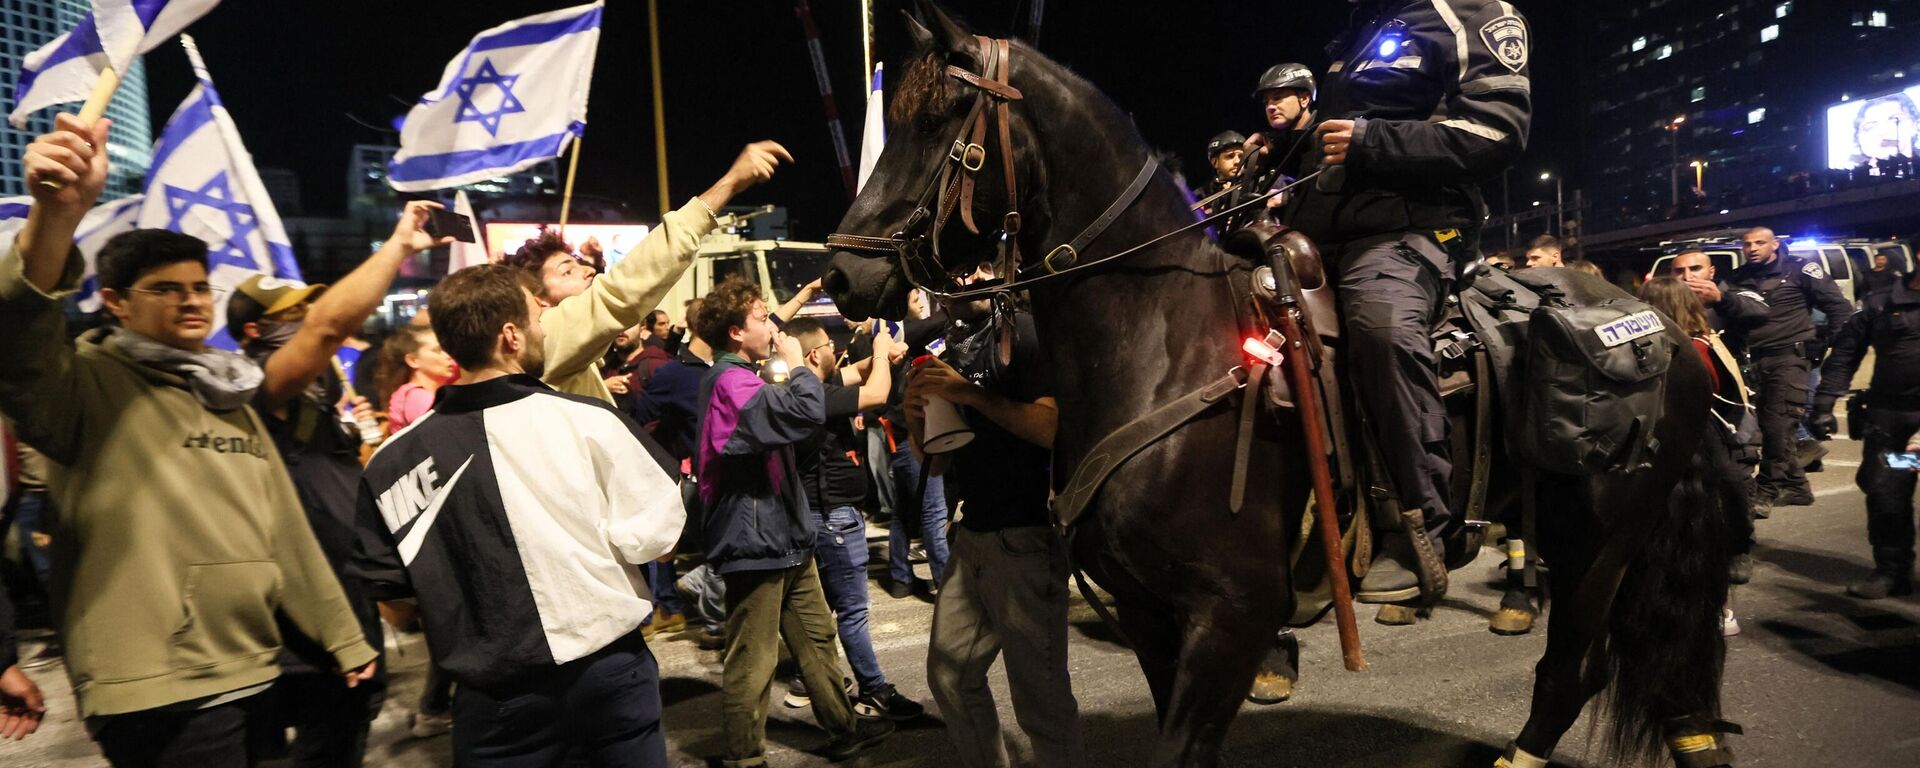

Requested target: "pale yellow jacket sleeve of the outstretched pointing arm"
[{"left": 540, "top": 200, "right": 714, "bottom": 401}]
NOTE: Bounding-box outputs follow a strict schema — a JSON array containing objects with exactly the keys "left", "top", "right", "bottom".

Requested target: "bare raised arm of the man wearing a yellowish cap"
[{"left": 261, "top": 200, "right": 453, "bottom": 411}]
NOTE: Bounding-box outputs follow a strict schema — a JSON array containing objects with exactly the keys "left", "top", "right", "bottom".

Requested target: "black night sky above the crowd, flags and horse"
[{"left": 135, "top": 0, "right": 1584, "bottom": 240}]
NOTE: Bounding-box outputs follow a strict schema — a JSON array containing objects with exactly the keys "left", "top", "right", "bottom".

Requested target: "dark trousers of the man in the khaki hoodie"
[{"left": 86, "top": 695, "right": 259, "bottom": 768}]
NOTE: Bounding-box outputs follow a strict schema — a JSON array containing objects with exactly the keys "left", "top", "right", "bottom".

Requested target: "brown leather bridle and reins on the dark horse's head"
[{"left": 828, "top": 36, "right": 1319, "bottom": 303}]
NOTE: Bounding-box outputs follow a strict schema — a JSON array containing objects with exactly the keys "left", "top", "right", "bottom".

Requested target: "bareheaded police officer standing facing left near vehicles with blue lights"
[{"left": 1726, "top": 227, "right": 1853, "bottom": 518}]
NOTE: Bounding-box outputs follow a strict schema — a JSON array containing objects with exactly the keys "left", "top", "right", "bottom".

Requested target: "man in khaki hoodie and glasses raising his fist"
[{"left": 0, "top": 115, "right": 376, "bottom": 768}]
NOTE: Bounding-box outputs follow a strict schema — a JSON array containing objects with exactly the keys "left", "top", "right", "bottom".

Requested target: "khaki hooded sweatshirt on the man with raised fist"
[{"left": 0, "top": 250, "right": 376, "bottom": 716}]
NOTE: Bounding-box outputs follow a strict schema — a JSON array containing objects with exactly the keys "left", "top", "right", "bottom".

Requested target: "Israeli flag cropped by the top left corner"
[{"left": 8, "top": 0, "right": 219, "bottom": 129}]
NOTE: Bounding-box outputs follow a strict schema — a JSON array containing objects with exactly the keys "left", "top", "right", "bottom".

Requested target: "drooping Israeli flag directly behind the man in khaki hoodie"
[{"left": 138, "top": 48, "right": 300, "bottom": 348}]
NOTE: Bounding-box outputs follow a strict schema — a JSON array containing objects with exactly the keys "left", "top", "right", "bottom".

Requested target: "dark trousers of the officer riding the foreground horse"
[{"left": 1334, "top": 232, "right": 1453, "bottom": 532}]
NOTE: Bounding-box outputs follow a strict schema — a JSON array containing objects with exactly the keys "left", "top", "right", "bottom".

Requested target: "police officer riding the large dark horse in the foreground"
[{"left": 1290, "top": 0, "right": 1532, "bottom": 603}]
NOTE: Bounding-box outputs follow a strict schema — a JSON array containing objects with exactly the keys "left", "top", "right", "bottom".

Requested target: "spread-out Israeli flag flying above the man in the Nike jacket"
[{"left": 388, "top": 2, "right": 603, "bottom": 192}]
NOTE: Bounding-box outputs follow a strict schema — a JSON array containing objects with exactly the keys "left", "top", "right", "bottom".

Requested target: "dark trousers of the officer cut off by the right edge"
[{"left": 1853, "top": 407, "right": 1920, "bottom": 576}]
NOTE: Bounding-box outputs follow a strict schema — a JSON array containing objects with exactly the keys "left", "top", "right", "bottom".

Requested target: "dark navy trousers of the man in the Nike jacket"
[{"left": 453, "top": 630, "right": 666, "bottom": 768}]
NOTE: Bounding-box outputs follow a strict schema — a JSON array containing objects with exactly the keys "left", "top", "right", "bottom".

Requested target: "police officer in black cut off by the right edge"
[{"left": 1809, "top": 270, "right": 1920, "bottom": 599}]
